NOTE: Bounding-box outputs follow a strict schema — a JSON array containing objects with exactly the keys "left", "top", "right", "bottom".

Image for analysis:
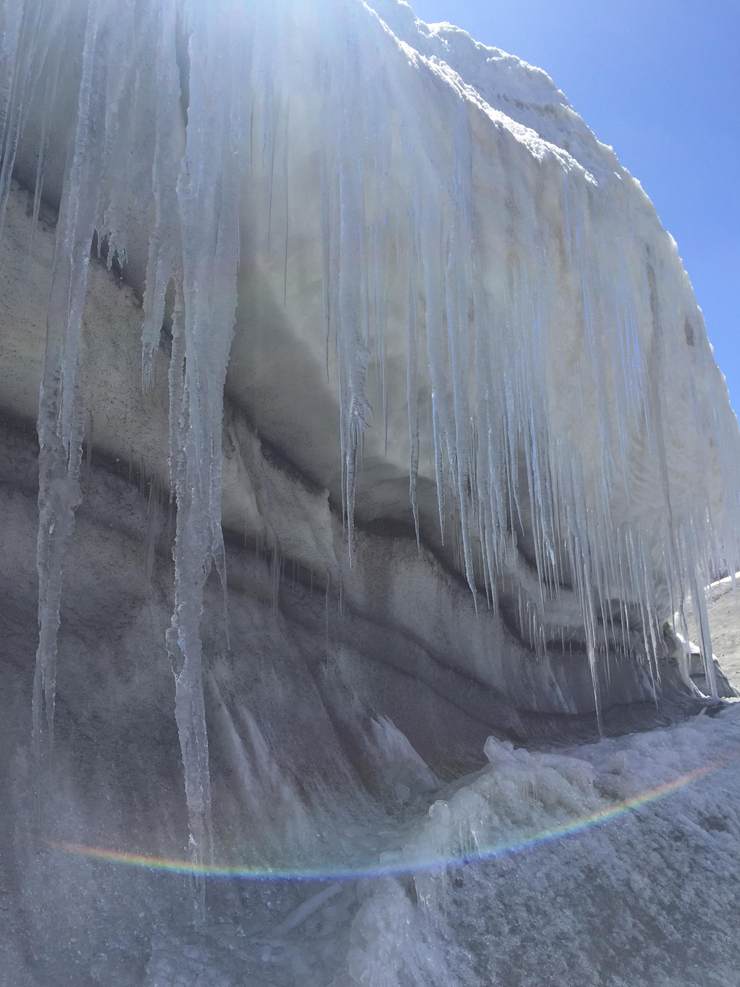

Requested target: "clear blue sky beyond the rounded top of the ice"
[{"left": 411, "top": 0, "right": 740, "bottom": 412}]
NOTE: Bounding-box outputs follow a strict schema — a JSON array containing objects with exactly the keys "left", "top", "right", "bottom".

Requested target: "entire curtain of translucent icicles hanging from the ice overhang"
[{"left": 0, "top": 0, "right": 740, "bottom": 888}]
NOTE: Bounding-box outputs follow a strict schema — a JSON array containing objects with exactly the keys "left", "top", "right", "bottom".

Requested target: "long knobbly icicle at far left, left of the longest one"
[{"left": 33, "top": 3, "right": 111, "bottom": 755}]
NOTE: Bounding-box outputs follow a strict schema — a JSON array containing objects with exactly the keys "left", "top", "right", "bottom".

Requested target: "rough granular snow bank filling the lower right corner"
[{"left": 356, "top": 708, "right": 738, "bottom": 984}]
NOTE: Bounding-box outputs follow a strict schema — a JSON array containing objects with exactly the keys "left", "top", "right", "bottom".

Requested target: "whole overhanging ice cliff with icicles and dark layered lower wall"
[{"left": 0, "top": 0, "right": 740, "bottom": 984}]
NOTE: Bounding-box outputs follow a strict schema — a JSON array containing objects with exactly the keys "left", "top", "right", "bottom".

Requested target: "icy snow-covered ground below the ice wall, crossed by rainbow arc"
[{"left": 7, "top": 604, "right": 740, "bottom": 987}]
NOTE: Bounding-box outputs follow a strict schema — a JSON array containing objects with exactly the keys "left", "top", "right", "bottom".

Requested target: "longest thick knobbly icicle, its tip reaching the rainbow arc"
[{"left": 160, "top": 2, "right": 248, "bottom": 915}]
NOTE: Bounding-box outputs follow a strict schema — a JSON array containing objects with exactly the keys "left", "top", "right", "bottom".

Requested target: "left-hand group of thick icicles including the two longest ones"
[{"left": 2, "top": 0, "right": 249, "bottom": 896}]
